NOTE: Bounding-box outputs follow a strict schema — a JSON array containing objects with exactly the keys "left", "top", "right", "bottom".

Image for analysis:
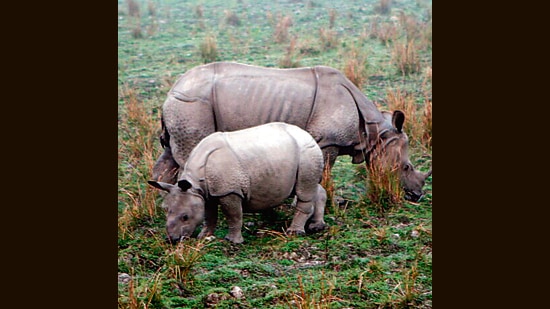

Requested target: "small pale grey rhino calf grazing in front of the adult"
[{"left": 149, "top": 122, "right": 327, "bottom": 243}]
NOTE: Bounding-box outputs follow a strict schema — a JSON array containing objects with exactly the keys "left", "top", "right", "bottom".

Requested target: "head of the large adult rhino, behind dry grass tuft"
[{"left": 369, "top": 110, "right": 432, "bottom": 202}]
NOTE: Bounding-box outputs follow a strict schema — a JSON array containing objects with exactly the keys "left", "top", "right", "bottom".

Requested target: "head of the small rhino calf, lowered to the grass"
[{"left": 148, "top": 180, "right": 205, "bottom": 243}]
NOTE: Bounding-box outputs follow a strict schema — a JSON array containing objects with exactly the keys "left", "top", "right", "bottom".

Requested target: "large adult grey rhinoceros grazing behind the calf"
[{"left": 152, "top": 62, "right": 431, "bottom": 201}]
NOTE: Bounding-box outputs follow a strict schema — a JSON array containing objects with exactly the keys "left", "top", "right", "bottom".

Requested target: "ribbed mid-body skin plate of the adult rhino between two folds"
[{"left": 213, "top": 64, "right": 316, "bottom": 131}]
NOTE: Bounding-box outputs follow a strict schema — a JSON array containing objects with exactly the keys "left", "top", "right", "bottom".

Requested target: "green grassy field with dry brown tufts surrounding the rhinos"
[{"left": 118, "top": 0, "right": 432, "bottom": 308}]
